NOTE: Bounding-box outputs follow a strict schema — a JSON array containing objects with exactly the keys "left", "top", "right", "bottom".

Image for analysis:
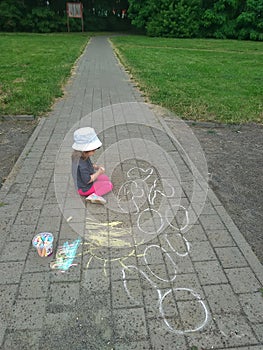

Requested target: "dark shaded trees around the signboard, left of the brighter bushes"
[{"left": 0, "top": 0, "right": 131, "bottom": 33}]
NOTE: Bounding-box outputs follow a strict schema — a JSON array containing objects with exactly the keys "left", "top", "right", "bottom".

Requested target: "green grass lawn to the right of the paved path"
[{"left": 111, "top": 36, "right": 263, "bottom": 123}]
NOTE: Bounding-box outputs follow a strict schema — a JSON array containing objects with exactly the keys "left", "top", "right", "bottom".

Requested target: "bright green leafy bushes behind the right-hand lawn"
[{"left": 128, "top": 0, "right": 263, "bottom": 40}]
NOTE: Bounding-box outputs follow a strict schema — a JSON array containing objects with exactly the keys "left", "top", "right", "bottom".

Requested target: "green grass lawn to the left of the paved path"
[{"left": 0, "top": 33, "right": 89, "bottom": 115}]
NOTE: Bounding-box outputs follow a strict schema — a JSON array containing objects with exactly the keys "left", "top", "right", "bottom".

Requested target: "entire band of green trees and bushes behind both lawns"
[{"left": 0, "top": 0, "right": 263, "bottom": 41}]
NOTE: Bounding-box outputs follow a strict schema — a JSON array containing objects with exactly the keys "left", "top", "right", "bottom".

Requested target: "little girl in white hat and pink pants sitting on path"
[{"left": 72, "top": 127, "right": 113, "bottom": 204}]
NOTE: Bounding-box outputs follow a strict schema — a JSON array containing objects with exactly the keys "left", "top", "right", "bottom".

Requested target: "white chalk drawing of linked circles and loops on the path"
[{"left": 118, "top": 167, "right": 209, "bottom": 334}]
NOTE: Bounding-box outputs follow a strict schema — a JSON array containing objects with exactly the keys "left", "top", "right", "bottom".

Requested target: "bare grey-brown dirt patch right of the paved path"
[{"left": 166, "top": 118, "right": 263, "bottom": 263}]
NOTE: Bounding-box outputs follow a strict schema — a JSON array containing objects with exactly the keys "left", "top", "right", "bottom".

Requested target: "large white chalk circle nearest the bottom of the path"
[{"left": 158, "top": 288, "right": 208, "bottom": 334}]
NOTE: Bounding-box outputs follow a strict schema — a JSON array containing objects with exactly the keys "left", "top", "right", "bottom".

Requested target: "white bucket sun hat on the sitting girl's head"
[{"left": 72, "top": 127, "right": 102, "bottom": 152}]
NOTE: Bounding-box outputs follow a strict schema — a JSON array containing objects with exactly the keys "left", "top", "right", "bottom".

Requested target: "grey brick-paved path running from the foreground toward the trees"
[{"left": 0, "top": 37, "right": 263, "bottom": 350}]
